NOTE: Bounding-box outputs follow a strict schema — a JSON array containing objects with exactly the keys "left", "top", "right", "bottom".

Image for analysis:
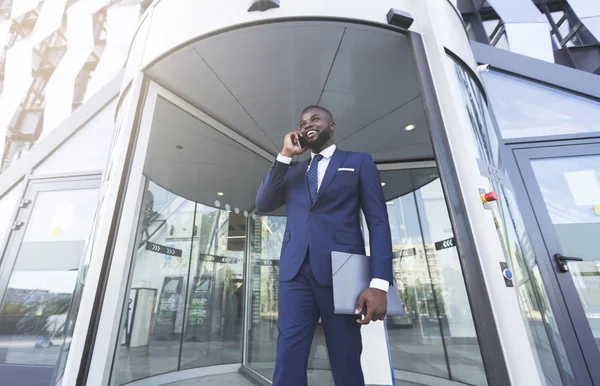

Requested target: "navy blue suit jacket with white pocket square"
[{"left": 256, "top": 149, "right": 393, "bottom": 287}]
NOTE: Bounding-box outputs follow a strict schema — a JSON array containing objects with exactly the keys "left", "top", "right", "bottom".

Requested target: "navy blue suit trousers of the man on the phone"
[{"left": 273, "top": 254, "right": 365, "bottom": 386}]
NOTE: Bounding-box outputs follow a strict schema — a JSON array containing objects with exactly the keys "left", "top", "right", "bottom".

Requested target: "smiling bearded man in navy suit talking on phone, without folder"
[{"left": 256, "top": 106, "right": 393, "bottom": 386}]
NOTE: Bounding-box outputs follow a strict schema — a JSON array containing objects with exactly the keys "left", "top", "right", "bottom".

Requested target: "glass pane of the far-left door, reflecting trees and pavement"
[{"left": 0, "top": 189, "right": 97, "bottom": 384}]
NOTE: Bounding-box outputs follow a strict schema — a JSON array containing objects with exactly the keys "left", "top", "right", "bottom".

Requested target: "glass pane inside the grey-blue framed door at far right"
[{"left": 531, "top": 155, "right": 600, "bottom": 348}]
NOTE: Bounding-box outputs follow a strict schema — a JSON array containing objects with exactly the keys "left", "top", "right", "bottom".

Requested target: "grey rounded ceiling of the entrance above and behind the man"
[{"left": 145, "top": 22, "right": 433, "bottom": 210}]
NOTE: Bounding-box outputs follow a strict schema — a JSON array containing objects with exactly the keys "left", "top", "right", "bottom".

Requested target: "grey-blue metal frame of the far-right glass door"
[{"left": 512, "top": 140, "right": 600, "bottom": 384}]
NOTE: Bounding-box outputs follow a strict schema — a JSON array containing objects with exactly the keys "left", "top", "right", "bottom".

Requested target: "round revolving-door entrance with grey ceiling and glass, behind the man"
[{"left": 83, "top": 15, "right": 516, "bottom": 386}]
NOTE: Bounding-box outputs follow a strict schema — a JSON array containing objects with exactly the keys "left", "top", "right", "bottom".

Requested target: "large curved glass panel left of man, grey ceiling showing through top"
[{"left": 110, "top": 98, "right": 269, "bottom": 385}]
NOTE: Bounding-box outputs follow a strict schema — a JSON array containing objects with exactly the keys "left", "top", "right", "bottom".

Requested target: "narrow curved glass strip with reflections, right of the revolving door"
[{"left": 454, "top": 58, "right": 572, "bottom": 384}]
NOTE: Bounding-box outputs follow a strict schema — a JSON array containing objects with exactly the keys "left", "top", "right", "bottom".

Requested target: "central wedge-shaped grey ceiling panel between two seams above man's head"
[{"left": 194, "top": 22, "right": 344, "bottom": 100}]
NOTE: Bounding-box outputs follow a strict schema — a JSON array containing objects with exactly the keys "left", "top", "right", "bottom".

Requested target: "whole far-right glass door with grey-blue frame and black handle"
[{"left": 516, "top": 145, "right": 600, "bottom": 382}]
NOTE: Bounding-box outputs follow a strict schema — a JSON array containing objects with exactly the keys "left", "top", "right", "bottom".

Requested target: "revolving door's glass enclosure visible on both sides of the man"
[{"left": 110, "top": 97, "right": 487, "bottom": 386}]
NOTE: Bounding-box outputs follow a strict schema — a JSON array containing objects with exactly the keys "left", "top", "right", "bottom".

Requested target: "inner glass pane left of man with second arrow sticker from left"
[{"left": 181, "top": 204, "right": 246, "bottom": 370}]
